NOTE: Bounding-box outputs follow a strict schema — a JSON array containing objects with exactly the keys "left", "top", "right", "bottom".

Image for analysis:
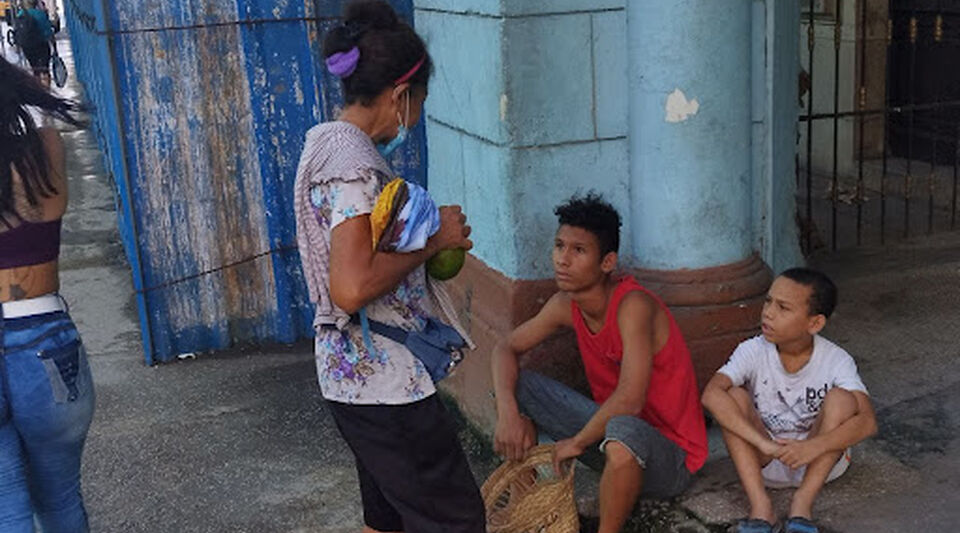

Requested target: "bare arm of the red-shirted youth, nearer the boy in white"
[{"left": 556, "top": 292, "right": 658, "bottom": 463}]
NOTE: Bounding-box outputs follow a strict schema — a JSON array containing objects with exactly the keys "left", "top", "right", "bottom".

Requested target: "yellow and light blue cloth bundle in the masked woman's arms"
[{"left": 370, "top": 178, "right": 440, "bottom": 253}]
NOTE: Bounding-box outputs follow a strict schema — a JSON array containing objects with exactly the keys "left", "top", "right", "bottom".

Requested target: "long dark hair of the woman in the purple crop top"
[{"left": 0, "top": 56, "right": 82, "bottom": 228}]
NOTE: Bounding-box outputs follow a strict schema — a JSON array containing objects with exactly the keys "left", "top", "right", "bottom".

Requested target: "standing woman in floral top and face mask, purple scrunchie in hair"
[{"left": 294, "top": 0, "right": 485, "bottom": 533}]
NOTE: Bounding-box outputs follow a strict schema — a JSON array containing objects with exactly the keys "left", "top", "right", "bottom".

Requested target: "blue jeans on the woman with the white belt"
[{"left": 0, "top": 311, "right": 94, "bottom": 533}]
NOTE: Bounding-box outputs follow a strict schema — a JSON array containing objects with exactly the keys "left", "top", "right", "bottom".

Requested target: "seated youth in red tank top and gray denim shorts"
[{"left": 492, "top": 194, "right": 707, "bottom": 533}]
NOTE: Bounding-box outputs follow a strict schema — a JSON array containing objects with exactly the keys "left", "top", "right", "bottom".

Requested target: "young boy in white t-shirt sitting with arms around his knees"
[{"left": 702, "top": 268, "right": 877, "bottom": 533}]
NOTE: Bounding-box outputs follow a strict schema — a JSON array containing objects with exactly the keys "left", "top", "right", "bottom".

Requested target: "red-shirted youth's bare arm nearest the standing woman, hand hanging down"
[{"left": 490, "top": 292, "right": 572, "bottom": 459}]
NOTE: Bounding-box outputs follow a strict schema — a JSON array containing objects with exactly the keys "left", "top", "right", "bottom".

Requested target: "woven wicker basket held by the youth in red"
[{"left": 480, "top": 445, "right": 580, "bottom": 533}]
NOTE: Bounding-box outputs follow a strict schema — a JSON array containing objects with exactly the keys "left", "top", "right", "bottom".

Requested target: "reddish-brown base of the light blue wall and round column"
[{"left": 443, "top": 255, "right": 772, "bottom": 431}]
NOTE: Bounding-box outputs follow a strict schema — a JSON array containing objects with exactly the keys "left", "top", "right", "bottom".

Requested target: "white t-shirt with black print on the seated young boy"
[{"left": 718, "top": 335, "right": 867, "bottom": 439}]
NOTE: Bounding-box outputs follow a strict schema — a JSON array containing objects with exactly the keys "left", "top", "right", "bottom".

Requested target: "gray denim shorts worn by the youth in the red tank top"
[{"left": 516, "top": 370, "right": 693, "bottom": 498}]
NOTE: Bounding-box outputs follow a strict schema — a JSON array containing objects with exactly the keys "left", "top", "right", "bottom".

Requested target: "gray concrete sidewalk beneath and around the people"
[{"left": 43, "top": 29, "right": 960, "bottom": 533}]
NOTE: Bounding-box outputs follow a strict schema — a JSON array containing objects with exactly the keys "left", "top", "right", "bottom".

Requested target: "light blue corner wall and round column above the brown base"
[{"left": 414, "top": 0, "right": 802, "bottom": 279}]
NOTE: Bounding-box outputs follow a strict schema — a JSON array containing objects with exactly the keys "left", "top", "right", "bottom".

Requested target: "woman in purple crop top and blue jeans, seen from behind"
[{"left": 0, "top": 57, "right": 94, "bottom": 533}]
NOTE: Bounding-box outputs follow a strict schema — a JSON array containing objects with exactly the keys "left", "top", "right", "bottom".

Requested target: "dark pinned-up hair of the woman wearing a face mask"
[{"left": 323, "top": 0, "right": 433, "bottom": 106}]
